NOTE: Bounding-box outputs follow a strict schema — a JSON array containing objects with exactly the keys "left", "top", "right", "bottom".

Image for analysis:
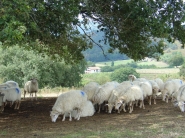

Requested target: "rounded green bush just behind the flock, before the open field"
[{"left": 111, "top": 68, "right": 140, "bottom": 83}]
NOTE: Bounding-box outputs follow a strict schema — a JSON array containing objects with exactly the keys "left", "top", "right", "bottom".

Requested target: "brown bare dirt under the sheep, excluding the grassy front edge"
[{"left": 0, "top": 97, "right": 185, "bottom": 138}]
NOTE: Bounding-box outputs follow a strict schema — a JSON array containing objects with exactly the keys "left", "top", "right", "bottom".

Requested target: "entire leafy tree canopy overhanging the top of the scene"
[{"left": 0, "top": 0, "right": 185, "bottom": 61}]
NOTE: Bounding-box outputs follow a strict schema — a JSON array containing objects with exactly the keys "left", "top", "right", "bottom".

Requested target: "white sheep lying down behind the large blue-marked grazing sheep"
[{"left": 66, "top": 100, "right": 95, "bottom": 119}]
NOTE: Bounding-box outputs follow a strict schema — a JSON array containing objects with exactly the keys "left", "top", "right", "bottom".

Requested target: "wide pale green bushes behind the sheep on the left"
[{"left": 0, "top": 46, "right": 86, "bottom": 88}]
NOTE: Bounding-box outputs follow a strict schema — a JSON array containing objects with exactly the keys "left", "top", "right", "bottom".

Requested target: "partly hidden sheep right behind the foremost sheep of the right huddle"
[{"left": 107, "top": 81, "right": 133, "bottom": 113}]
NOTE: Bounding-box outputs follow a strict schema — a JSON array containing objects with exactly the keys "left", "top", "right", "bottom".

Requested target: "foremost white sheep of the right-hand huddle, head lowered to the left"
[{"left": 115, "top": 85, "right": 145, "bottom": 113}]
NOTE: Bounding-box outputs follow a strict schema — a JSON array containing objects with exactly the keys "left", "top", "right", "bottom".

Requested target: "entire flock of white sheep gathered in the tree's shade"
[{"left": 0, "top": 75, "right": 185, "bottom": 122}]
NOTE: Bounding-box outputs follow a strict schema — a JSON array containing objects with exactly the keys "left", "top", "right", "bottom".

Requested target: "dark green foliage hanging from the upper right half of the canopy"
[{"left": 83, "top": 0, "right": 185, "bottom": 60}]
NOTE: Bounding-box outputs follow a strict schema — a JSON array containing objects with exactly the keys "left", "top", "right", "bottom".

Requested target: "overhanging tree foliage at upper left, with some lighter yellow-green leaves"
[{"left": 0, "top": 0, "right": 91, "bottom": 63}]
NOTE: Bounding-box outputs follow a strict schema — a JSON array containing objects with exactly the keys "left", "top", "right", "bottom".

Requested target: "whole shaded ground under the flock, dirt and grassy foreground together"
[{"left": 0, "top": 98, "right": 185, "bottom": 138}]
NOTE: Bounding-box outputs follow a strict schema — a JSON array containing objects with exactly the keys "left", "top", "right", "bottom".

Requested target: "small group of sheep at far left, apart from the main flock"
[{"left": 0, "top": 78, "right": 38, "bottom": 112}]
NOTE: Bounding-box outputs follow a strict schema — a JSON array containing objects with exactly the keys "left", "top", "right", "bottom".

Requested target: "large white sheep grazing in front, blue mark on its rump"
[{"left": 50, "top": 90, "right": 87, "bottom": 122}]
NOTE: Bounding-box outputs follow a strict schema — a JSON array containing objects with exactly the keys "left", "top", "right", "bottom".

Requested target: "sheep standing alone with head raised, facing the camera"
[{"left": 24, "top": 78, "right": 38, "bottom": 100}]
